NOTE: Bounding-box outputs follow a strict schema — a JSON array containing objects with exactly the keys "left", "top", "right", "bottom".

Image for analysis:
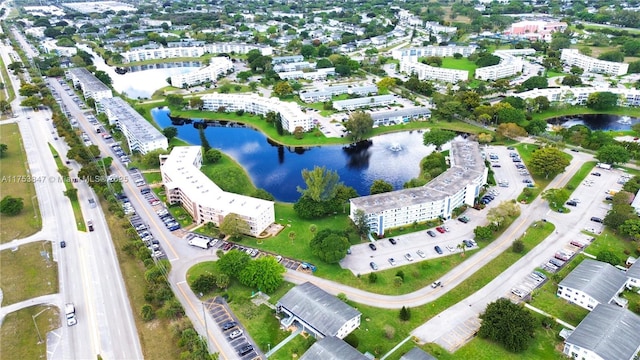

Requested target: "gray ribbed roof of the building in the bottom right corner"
[{"left": 566, "top": 304, "right": 640, "bottom": 360}]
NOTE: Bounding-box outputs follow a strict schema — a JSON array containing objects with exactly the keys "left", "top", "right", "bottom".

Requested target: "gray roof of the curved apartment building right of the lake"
[{"left": 351, "top": 141, "right": 485, "bottom": 213}]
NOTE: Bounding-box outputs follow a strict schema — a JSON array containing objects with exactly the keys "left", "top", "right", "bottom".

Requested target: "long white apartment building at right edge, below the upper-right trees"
[{"left": 513, "top": 86, "right": 640, "bottom": 106}]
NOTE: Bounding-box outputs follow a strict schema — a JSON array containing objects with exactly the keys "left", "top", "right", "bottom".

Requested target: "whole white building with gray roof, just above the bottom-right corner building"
[{"left": 556, "top": 259, "right": 627, "bottom": 311}]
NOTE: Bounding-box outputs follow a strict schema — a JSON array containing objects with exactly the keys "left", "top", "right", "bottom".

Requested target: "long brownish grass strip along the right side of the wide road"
[{"left": 100, "top": 201, "right": 180, "bottom": 359}]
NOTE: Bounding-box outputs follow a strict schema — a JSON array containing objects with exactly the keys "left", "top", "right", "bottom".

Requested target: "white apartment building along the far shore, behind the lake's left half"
[{"left": 201, "top": 93, "right": 313, "bottom": 133}]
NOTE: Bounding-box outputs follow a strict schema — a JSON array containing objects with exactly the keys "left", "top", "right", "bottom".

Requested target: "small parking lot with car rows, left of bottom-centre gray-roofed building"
[{"left": 204, "top": 297, "right": 262, "bottom": 360}]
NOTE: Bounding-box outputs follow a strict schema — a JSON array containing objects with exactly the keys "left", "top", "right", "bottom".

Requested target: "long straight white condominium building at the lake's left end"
[{"left": 96, "top": 97, "right": 169, "bottom": 155}]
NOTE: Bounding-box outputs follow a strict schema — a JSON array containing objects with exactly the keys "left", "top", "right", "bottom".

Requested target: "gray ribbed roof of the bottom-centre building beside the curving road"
[{"left": 278, "top": 282, "right": 361, "bottom": 336}]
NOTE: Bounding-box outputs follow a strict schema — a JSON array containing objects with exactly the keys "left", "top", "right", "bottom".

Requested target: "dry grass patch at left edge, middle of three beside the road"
[{"left": 0, "top": 241, "right": 57, "bottom": 306}]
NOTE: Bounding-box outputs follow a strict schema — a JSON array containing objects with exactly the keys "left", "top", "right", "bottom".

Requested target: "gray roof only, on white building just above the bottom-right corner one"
[{"left": 559, "top": 259, "right": 627, "bottom": 304}]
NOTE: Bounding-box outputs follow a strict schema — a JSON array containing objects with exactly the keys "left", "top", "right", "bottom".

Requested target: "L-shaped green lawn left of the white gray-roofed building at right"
[{"left": 529, "top": 255, "right": 589, "bottom": 326}]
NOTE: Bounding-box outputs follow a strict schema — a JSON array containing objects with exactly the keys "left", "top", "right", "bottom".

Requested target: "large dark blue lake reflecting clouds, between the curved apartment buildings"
[{"left": 151, "top": 109, "right": 446, "bottom": 202}]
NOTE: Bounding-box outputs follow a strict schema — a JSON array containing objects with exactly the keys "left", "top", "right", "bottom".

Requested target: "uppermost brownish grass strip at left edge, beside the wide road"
[{"left": 0, "top": 124, "right": 42, "bottom": 243}]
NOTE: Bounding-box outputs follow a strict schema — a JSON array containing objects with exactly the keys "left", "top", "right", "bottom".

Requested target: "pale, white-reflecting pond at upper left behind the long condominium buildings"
[{"left": 78, "top": 45, "right": 200, "bottom": 99}]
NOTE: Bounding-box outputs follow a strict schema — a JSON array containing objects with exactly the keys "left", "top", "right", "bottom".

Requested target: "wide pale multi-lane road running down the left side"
[{"left": 2, "top": 28, "right": 142, "bottom": 359}]
